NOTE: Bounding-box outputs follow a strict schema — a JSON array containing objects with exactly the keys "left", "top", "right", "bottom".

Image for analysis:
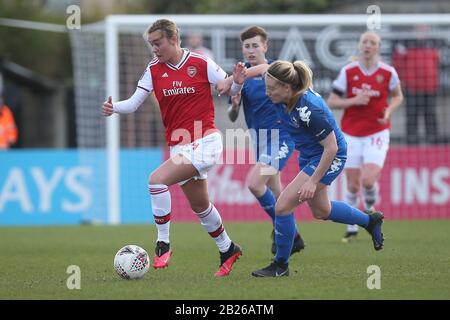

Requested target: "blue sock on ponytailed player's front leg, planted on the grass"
[{"left": 275, "top": 213, "right": 296, "bottom": 263}]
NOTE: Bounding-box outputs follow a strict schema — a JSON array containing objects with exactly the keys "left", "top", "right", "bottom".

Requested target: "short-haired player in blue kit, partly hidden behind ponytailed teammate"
[{"left": 228, "top": 26, "right": 305, "bottom": 254}]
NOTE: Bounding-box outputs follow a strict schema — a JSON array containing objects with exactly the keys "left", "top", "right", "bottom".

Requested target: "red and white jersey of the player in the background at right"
[{"left": 333, "top": 61, "right": 400, "bottom": 137}]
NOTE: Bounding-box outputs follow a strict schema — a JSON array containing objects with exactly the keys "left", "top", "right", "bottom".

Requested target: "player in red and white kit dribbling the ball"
[{"left": 102, "top": 19, "right": 245, "bottom": 277}]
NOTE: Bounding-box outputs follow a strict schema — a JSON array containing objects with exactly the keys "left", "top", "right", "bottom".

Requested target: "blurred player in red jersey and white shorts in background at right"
[{"left": 327, "top": 31, "right": 403, "bottom": 242}]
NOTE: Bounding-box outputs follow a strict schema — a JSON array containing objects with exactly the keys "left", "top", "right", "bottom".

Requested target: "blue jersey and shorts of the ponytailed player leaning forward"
[{"left": 277, "top": 89, "right": 347, "bottom": 184}]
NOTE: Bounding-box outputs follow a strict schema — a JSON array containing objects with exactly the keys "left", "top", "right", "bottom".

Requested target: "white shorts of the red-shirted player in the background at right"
[{"left": 344, "top": 129, "right": 389, "bottom": 168}]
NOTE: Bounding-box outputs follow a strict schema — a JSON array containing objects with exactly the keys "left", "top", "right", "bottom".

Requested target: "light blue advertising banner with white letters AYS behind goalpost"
[{"left": 0, "top": 149, "right": 163, "bottom": 225}]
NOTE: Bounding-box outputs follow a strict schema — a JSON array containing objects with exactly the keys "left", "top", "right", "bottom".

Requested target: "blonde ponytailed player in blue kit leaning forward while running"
[{"left": 252, "top": 61, "right": 384, "bottom": 277}]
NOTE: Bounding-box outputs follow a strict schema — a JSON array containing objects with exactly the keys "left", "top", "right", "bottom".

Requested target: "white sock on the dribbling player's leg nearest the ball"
[{"left": 148, "top": 184, "right": 171, "bottom": 243}]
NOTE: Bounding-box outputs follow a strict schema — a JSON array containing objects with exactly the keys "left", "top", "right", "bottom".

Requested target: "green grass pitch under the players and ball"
[{"left": 0, "top": 220, "right": 450, "bottom": 300}]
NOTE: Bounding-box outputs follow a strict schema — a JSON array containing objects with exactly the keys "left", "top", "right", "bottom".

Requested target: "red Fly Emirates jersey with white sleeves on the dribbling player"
[{"left": 138, "top": 49, "right": 227, "bottom": 146}]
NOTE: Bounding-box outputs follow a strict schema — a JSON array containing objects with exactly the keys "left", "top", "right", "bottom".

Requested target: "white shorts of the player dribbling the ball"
[{"left": 170, "top": 132, "right": 223, "bottom": 186}]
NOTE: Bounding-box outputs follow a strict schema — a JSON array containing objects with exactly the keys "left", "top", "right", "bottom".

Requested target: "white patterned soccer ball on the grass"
[{"left": 114, "top": 244, "right": 150, "bottom": 279}]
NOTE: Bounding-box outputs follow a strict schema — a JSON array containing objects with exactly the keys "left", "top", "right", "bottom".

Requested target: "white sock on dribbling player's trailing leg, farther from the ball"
[{"left": 195, "top": 203, "right": 231, "bottom": 252}]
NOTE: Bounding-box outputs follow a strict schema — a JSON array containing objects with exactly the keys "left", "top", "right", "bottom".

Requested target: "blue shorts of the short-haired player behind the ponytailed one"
[{"left": 253, "top": 134, "right": 295, "bottom": 171}]
